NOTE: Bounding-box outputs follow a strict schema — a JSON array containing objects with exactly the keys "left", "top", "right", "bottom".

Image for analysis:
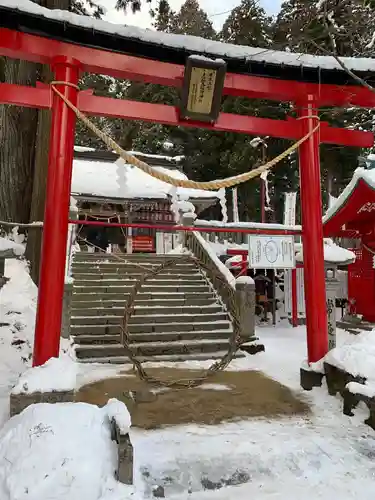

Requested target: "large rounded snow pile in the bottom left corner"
[{"left": 0, "top": 402, "right": 135, "bottom": 500}]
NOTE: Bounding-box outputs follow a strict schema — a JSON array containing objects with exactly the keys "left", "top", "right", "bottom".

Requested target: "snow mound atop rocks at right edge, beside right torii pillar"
[{"left": 325, "top": 330, "right": 375, "bottom": 383}]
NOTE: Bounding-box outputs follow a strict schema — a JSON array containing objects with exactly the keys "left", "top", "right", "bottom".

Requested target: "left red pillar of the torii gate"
[{"left": 33, "top": 57, "right": 80, "bottom": 366}]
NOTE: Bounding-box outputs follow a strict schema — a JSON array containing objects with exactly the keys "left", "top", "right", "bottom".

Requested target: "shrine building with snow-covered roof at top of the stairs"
[{"left": 71, "top": 146, "right": 218, "bottom": 254}]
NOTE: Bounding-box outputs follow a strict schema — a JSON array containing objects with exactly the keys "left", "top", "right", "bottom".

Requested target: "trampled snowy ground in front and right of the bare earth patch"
[{"left": 132, "top": 325, "right": 375, "bottom": 500}]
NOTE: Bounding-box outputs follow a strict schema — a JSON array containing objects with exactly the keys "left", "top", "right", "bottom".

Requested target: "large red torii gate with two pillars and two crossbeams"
[{"left": 0, "top": 0, "right": 375, "bottom": 365}]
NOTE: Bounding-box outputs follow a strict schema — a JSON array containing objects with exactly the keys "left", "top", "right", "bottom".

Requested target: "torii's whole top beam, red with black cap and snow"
[{"left": 0, "top": 0, "right": 375, "bottom": 107}]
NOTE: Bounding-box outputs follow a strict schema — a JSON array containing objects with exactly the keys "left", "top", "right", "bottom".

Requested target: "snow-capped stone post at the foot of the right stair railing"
[{"left": 235, "top": 276, "right": 255, "bottom": 342}]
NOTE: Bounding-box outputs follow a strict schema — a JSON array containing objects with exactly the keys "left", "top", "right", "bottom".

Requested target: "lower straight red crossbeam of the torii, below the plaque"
[{"left": 0, "top": 83, "right": 373, "bottom": 148}]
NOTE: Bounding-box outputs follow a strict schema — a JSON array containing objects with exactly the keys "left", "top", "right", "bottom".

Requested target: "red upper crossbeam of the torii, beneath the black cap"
[{"left": 0, "top": 28, "right": 375, "bottom": 107}]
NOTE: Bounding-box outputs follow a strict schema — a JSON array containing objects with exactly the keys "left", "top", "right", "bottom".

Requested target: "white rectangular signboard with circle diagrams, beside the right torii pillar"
[{"left": 249, "top": 235, "right": 296, "bottom": 269}]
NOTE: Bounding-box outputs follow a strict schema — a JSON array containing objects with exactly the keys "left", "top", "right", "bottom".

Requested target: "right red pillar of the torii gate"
[{"left": 298, "top": 95, "right": 328, "bottom": 363}]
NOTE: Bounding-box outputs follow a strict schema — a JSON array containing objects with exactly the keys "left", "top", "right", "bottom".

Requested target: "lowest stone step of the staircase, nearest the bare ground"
[{"left": 74, "top": 339, "right": 228, "bottom": 359}]
